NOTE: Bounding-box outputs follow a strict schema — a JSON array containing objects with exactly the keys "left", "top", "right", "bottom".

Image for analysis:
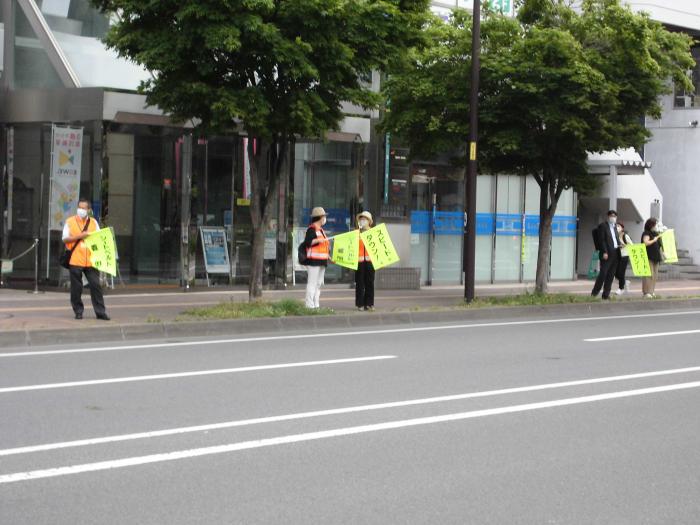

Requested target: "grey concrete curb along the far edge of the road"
[{"left": 0, "top": 299, "right": 700, "bottom": 348}]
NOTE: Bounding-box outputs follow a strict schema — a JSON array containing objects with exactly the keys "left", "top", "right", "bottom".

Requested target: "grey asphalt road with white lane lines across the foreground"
[{"left": 0, "top": 311, "right": 700, "bottom": 525}]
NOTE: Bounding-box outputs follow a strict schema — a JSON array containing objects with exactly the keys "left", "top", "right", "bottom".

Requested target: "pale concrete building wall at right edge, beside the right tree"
[{"left": 644, "top": 94, "right": 700, "bottom": 261}]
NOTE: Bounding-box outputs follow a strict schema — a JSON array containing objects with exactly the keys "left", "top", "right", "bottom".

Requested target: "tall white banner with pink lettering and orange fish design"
[{"left": 49, "top": 126, "right": 83, "bottom": 231}]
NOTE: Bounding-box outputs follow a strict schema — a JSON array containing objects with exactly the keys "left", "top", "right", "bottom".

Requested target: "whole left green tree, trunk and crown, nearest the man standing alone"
[{"left": 92, "top": 0, "right": 429, "bottom": 299}]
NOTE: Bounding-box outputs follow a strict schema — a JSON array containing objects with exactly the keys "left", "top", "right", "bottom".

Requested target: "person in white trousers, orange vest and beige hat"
[{"left": 304, "top": 206, "right": 331, "bottom": 308}]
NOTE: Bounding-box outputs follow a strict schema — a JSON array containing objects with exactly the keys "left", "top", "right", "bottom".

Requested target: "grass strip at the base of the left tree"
[{"left": 178, "top": 299, "right": 335, "bottom": 321}]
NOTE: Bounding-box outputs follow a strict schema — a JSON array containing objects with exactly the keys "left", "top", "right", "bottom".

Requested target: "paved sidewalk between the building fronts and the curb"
[{"left": 0, "top": 280, "right": 700, "bottom": 347}]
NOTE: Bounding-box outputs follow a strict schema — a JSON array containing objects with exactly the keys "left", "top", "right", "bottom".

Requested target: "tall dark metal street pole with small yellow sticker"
[{"left": 464, "top": 0, "right": 481, "bottom": 303}]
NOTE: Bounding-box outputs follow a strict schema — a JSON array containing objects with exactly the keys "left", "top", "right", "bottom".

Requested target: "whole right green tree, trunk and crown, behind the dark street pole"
[{"left": 382, "top": 0, "right": 693, "bottom": 293}]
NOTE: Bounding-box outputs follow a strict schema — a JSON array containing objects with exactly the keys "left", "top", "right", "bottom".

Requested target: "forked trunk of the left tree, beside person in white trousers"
[{"left": 248, "top": 137, "right": 287, "bottom": 301}]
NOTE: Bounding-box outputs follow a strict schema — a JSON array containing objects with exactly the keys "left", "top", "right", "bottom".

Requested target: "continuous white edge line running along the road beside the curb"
[{"left": 0, "top": 310, "right": 700, "bottom": 357}]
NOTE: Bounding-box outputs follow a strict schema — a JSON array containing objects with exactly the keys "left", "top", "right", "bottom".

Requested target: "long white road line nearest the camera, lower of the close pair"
[{"left": 0, "top": 381, "right": 700, "bottom": 484}]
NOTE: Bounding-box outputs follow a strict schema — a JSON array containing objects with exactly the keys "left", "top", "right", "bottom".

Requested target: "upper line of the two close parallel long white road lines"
[{"left": 0, "top": 366, "right": 700, "bottom": 457}]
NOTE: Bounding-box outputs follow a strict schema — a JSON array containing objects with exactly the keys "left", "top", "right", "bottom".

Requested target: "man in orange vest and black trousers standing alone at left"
[{"left": 62, "top": 199, "right": 109, "bottom": 321}]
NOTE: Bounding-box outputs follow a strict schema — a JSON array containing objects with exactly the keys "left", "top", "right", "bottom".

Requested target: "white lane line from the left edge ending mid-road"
[{"left": 0, "top": 355, "right": 396, "bottom": 394}]
